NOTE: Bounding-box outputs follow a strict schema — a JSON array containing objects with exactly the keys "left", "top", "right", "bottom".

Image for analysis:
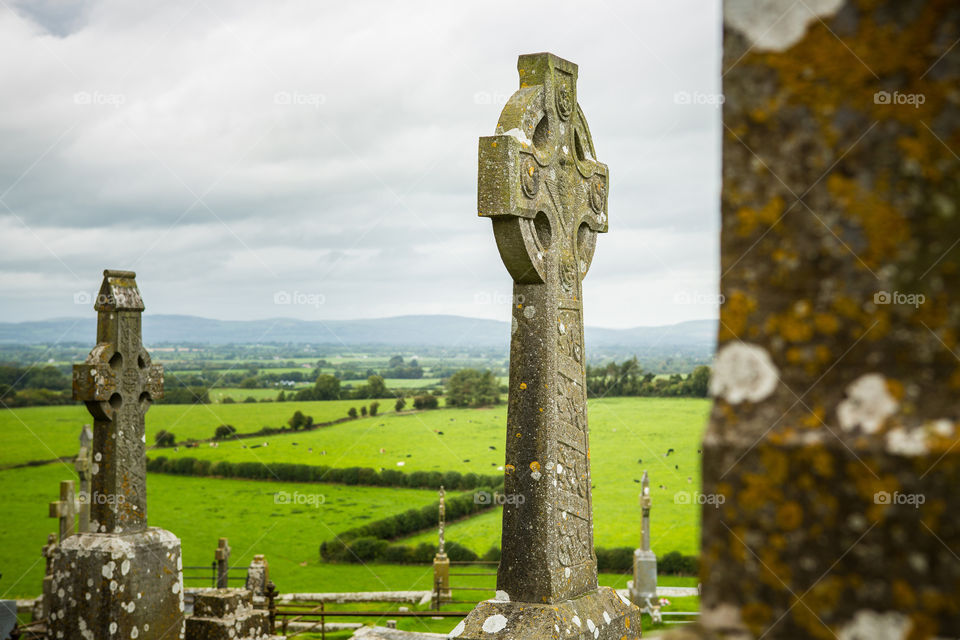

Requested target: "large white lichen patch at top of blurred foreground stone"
[{"left": 723, "top": 0, "right": 843, "bottom": 51}]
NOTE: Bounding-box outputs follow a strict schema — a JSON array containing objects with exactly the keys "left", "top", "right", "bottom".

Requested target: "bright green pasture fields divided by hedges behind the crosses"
[{"left": 0, "top": 390, "right": 709, "bottom": 638}]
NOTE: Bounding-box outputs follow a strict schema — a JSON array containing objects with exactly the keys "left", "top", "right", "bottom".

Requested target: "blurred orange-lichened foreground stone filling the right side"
[{"left": 664, "top": 0, "right": 960, "bottom": 640}]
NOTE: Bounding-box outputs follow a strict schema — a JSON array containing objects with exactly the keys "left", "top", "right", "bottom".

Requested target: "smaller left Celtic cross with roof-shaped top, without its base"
[{"left": 73, "top": 270, "right": 163, "bottom": 533}]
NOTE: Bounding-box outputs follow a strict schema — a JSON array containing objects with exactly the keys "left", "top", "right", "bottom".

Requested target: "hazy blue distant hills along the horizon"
[{"left": 0, "top": 315, "right": 717, "bottom": 351}]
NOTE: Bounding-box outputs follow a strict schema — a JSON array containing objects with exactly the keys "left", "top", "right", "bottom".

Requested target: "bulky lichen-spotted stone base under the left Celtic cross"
[{"left": 47, "top": 528, "right": 184, "bottom": 640}]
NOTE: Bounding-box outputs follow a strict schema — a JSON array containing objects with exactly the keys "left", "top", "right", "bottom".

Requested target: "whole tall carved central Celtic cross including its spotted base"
[{"left": 452, "top": 53, "right": 640, "bottom": 640}]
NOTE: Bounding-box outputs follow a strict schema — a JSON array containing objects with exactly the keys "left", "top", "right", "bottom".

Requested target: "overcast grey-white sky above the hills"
[{"left": 0, "top": 0, "right": 721, "bottom": 327}]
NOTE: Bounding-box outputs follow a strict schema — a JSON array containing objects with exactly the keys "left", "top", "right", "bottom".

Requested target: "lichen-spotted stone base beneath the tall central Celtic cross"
[{"left": 449, "top": 587, "right": 640, "bottom": 640}]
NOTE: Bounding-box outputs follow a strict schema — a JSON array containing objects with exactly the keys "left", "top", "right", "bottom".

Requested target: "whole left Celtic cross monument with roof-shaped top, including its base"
[{"left": 48, "top": 271, "right": 183, "bottom": 640}]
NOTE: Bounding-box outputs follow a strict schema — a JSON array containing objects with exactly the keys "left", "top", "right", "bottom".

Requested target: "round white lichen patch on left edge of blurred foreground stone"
[{"left": 710, "top": 342, "right": 780, "bottom": 404}]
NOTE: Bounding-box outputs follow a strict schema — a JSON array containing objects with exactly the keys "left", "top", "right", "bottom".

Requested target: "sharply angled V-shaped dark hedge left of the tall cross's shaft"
[{"left": 320, "top": 490, "right": 493, "bottom": 562}]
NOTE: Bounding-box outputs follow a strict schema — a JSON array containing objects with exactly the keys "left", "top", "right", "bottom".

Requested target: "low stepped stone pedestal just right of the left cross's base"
[{"left": 186, "top": 589, "right": 271, "bottom": 640}]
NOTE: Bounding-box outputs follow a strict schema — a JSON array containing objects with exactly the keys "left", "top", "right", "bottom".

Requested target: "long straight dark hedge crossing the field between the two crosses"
[{"left": 147, "top": 456, "right": 503, "bottom": 490}]
